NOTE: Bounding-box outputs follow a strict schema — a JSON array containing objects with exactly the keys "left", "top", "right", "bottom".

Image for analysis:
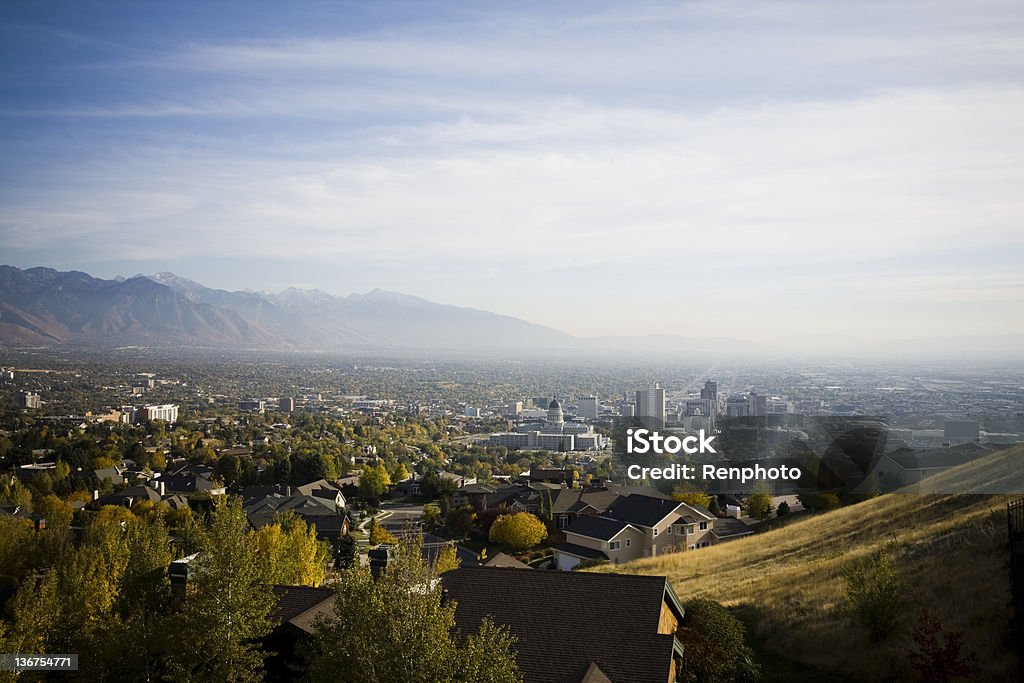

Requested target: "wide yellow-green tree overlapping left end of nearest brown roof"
[{"left": 299, "top": 536, "right": 521, "bottom": 683}]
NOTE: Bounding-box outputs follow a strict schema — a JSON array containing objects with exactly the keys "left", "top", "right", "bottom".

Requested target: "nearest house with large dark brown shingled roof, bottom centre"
[{"left": 441, "top": 566, "right": 684, "bottom": 683}]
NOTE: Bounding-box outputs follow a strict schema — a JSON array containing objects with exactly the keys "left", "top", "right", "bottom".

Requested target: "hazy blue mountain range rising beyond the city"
[{"left": 0, "top": 265, "right": 577, "bottom": 351}]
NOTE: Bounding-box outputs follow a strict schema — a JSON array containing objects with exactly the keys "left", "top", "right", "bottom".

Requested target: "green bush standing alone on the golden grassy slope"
[{"left": 843, "top": 549, "right": 904, "bottom": 641}]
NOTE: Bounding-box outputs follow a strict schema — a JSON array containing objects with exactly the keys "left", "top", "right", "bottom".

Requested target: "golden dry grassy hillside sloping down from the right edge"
[{"left": 597, "top": 446, "right": 1024, "bottom": 680}]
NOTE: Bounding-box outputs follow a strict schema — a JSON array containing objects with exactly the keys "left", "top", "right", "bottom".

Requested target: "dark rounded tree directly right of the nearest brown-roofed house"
[{"left": 676, "top": 598, "right": 760, "bottom": 682}]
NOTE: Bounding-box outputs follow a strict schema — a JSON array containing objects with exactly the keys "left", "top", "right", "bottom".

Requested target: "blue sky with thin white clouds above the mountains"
[{"left": 0, "top": 0, "right": 1024, "bottom": 346}]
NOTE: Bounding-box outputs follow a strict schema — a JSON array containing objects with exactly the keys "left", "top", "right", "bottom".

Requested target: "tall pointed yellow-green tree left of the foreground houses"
[{"left": 160, "top": 499, "right": 273, "bottom": 681}]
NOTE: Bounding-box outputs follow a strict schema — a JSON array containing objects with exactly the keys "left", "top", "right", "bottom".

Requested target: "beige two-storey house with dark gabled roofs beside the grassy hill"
[{"left": 555, "top": 494, "right": 716, "bottom": 570}]
